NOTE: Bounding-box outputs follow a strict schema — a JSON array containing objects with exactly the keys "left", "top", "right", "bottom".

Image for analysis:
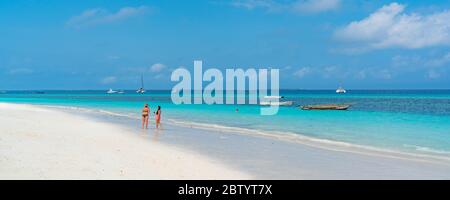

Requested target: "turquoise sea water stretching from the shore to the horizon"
[{"left": 0, "top": 90, "right": 450, "bottom": 157}]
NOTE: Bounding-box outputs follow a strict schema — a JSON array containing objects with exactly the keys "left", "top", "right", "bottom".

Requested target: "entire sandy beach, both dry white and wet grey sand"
[{"left": 0, "top": 103, "right": 450, "bottom": 179}]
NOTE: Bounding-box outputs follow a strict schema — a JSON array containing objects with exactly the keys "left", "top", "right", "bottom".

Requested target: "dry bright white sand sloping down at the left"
[{"left": 0, "top": 103, "right": 251, "bottom": 179}]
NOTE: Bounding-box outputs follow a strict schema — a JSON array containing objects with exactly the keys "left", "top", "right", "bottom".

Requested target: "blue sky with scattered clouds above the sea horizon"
[{"left": 0, "top": 0, "right": 450, "bottom": 90}]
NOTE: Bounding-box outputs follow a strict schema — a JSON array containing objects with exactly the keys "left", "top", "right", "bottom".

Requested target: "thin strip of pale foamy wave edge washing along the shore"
[{"left": 42, "top": 105, "right": 450, "bottom": 166}]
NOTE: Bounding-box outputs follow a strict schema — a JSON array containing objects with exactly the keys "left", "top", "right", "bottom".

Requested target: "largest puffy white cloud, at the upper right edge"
[{"left": 335, "top": 3, "right": 450, "bottom": 49}]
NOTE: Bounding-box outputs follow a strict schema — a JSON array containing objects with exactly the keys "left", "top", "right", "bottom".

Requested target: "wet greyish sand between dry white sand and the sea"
[{"left": 0, "top": 103, "right": 450, "bottom": 179}]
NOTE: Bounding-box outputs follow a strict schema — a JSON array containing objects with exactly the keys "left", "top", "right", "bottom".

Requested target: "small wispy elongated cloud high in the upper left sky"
[{"left": 66, "top": 6, "right": 148, "bottom": 28}]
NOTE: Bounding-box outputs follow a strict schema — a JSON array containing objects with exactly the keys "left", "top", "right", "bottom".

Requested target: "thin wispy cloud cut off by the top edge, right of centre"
[{"left": 231, "top": 0, "right": 341, "bottom": 13}]
